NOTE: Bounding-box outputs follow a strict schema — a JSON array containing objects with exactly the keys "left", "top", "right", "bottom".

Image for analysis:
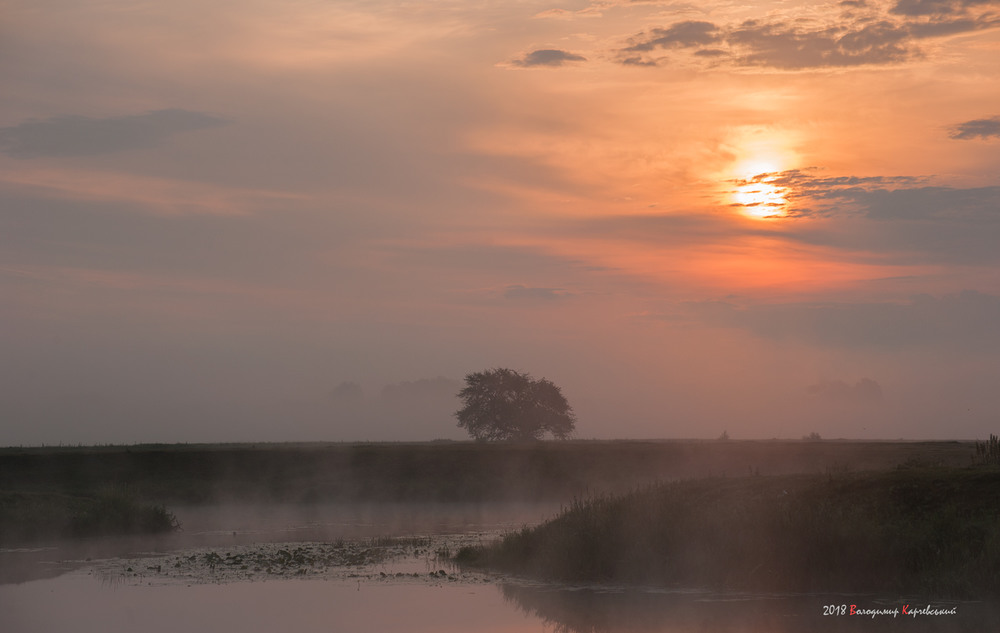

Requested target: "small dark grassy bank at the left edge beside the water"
[{"left": 0, "top": 489, "right": 178, "bottom": 546}]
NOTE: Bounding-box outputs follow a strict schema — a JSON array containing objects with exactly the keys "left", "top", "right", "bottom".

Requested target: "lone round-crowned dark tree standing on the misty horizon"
[{"left": 455, "top": 368, "right": 576, "bottom": 441}]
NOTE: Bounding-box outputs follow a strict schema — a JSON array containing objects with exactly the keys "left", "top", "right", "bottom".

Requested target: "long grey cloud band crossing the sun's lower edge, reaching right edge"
[{"left": 565, "top": 169, "right": 1000, "bottom": 266}]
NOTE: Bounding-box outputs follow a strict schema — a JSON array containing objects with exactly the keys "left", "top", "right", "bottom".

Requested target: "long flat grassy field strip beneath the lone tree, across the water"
[{"left": 0, "top": 440, "right": 975, "bottom": 504}]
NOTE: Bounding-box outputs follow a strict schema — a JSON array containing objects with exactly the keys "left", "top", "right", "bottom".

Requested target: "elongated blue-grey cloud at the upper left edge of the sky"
[{"left": 0, "top": 108, "right": 226, "bottom": 159}]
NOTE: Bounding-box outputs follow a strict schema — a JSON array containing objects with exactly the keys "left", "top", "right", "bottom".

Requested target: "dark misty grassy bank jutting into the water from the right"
[{"left": 457, "top": 467, "right": 1000, "bottom": 598}]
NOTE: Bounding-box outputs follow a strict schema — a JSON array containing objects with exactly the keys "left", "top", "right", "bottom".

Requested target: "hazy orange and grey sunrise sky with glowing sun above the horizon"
[{"left": 0, "top": 0, "right": 1000, "bottom": 445}]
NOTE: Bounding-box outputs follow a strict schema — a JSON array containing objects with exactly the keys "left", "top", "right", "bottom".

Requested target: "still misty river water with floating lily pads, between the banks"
[{"left": 0, "top": 504, "right": 1000, "bottom": 633}]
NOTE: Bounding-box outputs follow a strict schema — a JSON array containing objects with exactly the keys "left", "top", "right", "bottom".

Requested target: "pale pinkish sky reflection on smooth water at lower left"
[{"left": 0, "top": 572, "right": 528, "bottom": 633}]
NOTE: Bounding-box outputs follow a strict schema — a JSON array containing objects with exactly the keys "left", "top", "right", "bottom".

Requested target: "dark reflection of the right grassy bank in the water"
[{"left": 500, "top": 583, "right": 1000, "bottom": 633}]
